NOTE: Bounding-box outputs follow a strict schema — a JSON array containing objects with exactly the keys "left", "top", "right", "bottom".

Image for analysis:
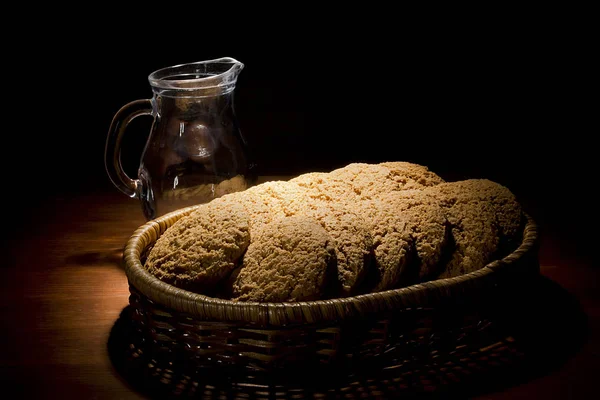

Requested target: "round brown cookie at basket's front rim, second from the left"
[{"left": 232, "top": 215, "right": 336, "bottom": 302}]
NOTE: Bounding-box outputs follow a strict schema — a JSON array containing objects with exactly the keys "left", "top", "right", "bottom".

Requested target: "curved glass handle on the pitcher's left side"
[{"left": 104, "top": 99, "right": 154, "bottom": 198}]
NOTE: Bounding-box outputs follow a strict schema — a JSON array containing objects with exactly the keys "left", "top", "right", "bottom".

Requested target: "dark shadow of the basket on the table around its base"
[{"left": 108, "top": 277, "right": 588, "bottom": 399}]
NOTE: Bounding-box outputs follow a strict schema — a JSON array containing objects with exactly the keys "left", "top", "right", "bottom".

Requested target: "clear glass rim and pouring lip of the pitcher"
[{"left": 148, "top": 57, "right": 244, "bottom": 90}]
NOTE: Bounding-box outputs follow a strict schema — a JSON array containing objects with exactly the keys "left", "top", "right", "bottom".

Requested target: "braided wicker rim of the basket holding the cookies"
[{"left": 123, "top": 205, "right": 538, "bottom": 326}]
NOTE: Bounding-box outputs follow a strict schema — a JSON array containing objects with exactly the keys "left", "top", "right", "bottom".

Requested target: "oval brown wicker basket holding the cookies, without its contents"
[{"left": 124, "top": 207, "right": 539, "bottom": 385}]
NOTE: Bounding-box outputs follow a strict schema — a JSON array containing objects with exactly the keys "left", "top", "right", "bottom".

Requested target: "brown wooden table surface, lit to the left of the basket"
[{"left": 0, "top": 190, "right": 600, "bottom": 399}]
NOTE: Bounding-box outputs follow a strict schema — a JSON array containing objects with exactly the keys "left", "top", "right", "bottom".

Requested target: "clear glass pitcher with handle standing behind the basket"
[{"left": 105, "top": 57, "right": 256, "bottom": 220}]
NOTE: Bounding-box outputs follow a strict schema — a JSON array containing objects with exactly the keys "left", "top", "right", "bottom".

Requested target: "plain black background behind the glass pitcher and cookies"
[{"left": 2, "top": 15, "right": 597, "bottom": 260}]
